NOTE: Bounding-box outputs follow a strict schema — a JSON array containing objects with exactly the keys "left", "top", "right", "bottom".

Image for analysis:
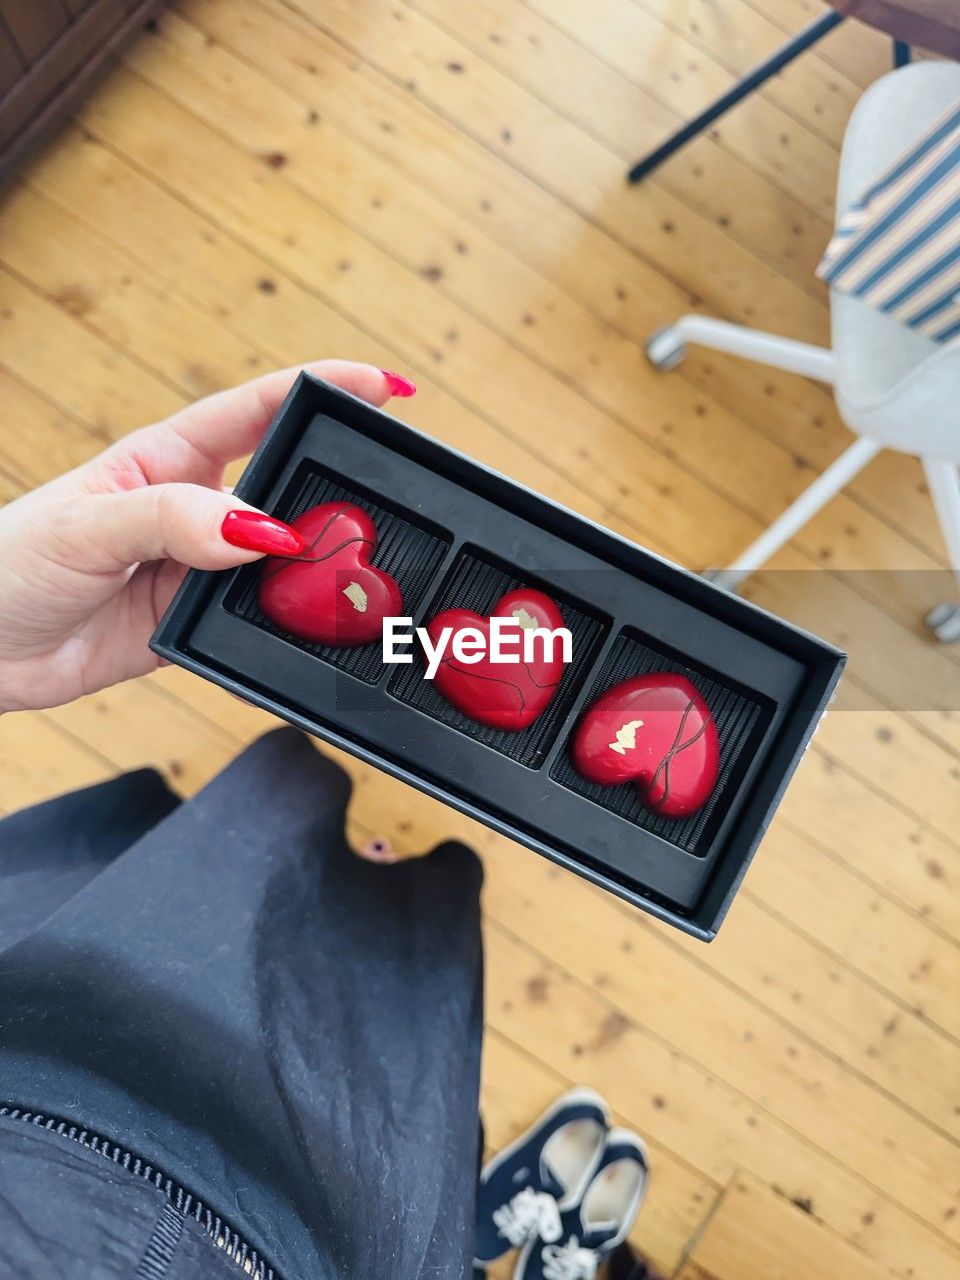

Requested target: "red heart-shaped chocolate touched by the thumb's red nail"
[{"left": 259, "top": 502, "right": 403, "bottom": 646}]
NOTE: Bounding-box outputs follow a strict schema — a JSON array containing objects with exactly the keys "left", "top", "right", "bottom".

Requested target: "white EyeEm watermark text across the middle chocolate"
[{"left": 383, "top": 617, "right": 573, "bottom": 680}]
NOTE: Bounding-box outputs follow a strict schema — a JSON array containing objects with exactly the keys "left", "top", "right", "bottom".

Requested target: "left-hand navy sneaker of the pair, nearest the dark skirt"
[{"left": 475, "top": 1089, "right": 609, "bottom": 1267}]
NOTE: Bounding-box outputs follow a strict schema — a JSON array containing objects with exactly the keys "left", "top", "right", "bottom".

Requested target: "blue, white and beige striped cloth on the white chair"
[{"left": 817, "top": 102, "right": 960, "bottom": 342}]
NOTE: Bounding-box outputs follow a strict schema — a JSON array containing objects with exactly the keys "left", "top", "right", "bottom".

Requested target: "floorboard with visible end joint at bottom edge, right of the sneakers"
[{"left": 690, "top": 1174, "right": 887, "bottom": 1280}]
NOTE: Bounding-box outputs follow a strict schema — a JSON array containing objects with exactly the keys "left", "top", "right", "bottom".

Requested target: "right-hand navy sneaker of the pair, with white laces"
[{"left": 513, "top": 1129, "right": 649, "bottom": 1280}]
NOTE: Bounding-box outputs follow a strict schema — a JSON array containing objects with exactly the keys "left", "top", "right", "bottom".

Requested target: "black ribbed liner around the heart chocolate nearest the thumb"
[{"left": 224, "top": 465, "right": 451, "bottom": 685}]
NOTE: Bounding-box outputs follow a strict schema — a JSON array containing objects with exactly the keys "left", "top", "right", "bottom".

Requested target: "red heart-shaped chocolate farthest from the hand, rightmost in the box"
[{"left": 572, "top": 672, "right": 719, "bottom": 818}]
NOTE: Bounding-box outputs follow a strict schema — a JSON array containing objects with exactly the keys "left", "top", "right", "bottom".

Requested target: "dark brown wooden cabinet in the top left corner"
[{"left": 0, "top": 0, "right": 163, "bottom": 182}]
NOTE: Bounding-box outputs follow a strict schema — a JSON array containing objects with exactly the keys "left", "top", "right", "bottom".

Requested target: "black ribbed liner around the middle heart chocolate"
[{"left": 387, "top": 548, "right": 607, "bottom": 768}]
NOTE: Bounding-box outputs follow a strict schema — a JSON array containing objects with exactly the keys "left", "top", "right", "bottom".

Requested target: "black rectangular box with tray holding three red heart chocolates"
[{"left": 152, "top": 375, "right": 845, "bottom": 940}]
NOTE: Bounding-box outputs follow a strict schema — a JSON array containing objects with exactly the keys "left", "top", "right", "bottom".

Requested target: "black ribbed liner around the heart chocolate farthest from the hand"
[{"left": 550, "top": 630, "right": 772, "bottom": 854}]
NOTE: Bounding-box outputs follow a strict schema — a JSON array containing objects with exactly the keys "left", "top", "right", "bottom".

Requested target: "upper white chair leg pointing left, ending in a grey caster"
[{"left": 646, "top": 315, "right": 835, "bottom": 383}]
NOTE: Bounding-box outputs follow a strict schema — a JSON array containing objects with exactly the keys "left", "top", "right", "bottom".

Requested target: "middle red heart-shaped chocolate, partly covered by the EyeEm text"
[{"left": 426, "top": 588, "right": 566, "bottom": 730}]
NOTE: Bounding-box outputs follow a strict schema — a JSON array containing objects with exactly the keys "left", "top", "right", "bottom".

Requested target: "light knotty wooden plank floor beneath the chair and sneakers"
[{"left": 0, "top": 0, "right": 960, "bottom": 1280}]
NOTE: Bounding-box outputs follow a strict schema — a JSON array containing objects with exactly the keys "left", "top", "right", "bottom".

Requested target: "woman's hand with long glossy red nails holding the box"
[{"left": 0, "top": 360, "right": 413, "bottom": 712}]
